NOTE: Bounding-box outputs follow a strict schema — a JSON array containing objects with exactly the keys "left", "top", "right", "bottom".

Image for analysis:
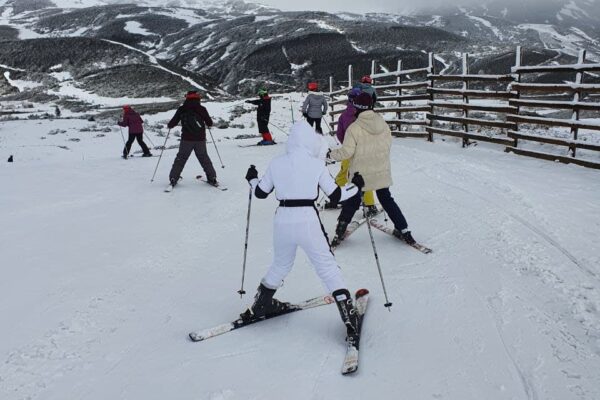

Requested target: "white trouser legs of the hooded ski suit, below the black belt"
[{"left": 262, "top": 207, "right": 347, "bottom": 293}]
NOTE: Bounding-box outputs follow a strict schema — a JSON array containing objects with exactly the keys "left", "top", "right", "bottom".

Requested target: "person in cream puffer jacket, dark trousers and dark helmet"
[{"left": 330, "top": 92, "right": 415, "bottom": 244}]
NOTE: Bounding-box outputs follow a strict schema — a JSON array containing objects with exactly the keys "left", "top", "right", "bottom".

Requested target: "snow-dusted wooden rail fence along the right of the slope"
[{"left": 329, "top": 47, "right": 600, "bottom": 169}]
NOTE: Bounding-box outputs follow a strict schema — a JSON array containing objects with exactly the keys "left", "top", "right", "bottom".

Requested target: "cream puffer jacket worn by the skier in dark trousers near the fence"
[{"left": 330, "top": 110, "right": 392, "bottom": 191}]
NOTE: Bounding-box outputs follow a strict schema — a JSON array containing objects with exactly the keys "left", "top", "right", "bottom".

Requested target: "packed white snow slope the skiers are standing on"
[{"left": 0, "top": 94, "right": 600, "bottom": 400}]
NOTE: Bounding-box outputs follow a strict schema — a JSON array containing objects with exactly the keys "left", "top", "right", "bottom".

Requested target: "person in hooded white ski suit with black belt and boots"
[{"left": 241, "top": 121, "right": 364, "bottom": 337}]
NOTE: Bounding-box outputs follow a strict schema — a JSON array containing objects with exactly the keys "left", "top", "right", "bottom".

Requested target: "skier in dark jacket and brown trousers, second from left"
[{"left": 167, "top": 90, "right": 217, "bottom": 186}]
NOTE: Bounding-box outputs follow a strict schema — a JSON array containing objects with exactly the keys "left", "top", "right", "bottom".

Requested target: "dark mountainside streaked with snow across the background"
[{"left": 0, "top": 0, "right": 600, "bottom": 109}]
